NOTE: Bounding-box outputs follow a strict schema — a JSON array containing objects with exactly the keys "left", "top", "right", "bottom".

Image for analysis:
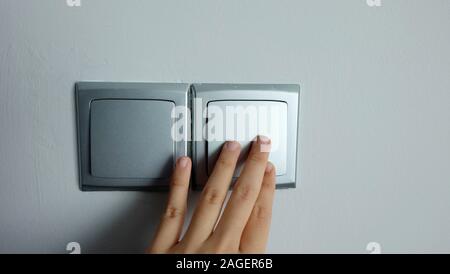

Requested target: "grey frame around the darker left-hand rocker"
[{"left": 75, "top": 82, "right": 190, "bottom": 191}]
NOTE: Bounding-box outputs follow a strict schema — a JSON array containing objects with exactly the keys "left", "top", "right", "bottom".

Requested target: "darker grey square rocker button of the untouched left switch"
[{"left": 90, "top": 100, "right": 175, "bottom": 179}]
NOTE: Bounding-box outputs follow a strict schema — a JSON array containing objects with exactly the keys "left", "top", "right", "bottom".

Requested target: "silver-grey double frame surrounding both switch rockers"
[{"left": 75, "top": 82, "right": 300, "bottom": 191}]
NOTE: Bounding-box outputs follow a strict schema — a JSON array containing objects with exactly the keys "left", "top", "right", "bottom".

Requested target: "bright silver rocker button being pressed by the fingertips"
[{"left": 207, "top": 101, "right": 287, "bottom": 177}]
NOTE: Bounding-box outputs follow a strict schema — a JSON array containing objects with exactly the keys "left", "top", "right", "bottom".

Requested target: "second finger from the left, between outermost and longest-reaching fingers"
[{"left": 182, "top": 141, "right": 240, "bottom": 246}]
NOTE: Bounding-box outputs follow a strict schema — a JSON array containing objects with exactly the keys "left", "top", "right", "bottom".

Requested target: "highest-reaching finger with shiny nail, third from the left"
[{"left": 212, "top": 136, "right": 270, "bottom": 247}]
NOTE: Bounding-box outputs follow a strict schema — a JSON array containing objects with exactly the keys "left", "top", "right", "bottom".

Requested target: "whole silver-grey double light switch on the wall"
[{"left": 76, "top": 82, "right": 299, "bottom": 190}]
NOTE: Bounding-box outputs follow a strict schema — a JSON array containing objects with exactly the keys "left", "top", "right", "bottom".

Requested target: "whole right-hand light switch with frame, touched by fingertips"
[{"left": 191, "top": 84, "right": 300, "bottom": 189}]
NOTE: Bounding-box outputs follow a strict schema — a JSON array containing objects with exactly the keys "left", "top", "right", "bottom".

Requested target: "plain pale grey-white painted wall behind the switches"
[{"left": 0, "top": 0, "right": 450, "bottom": 253}]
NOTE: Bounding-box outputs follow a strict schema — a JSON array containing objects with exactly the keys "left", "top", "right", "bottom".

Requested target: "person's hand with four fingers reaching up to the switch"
[{"left": 147, "top": 136, "right": 275, "bottom": 253}]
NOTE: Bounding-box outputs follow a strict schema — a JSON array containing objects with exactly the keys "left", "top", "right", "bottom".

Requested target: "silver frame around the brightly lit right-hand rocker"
[{"left": 191, "top": 84, "right": 300, "bottom": 190}]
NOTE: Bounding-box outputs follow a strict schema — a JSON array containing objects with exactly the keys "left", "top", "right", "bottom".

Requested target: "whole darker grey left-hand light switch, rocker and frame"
[{"left": 76, "top": 82, "right": 189, "bottom": 190}]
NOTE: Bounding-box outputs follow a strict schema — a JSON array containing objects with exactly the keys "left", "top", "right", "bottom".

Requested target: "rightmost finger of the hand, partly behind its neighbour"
[{"left": 240, "top": 163, "right": 275, "bottom": 253}]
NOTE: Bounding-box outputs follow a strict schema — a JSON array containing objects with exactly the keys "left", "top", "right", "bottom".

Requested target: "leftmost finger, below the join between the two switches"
[{"left": 149, "top": 157, "right": 191, "bottom": 253}]
